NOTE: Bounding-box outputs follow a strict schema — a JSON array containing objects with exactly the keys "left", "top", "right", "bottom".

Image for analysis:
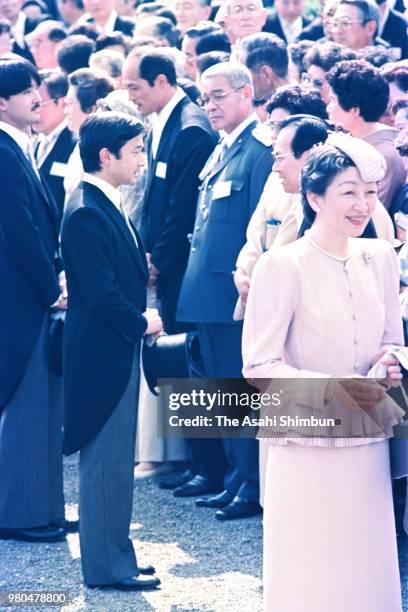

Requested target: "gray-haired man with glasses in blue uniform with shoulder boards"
[{"left": 177, "top": 63, "right": 272, "bottom": 520}]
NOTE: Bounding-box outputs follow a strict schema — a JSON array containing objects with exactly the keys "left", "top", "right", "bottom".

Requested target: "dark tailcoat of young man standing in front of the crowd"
[{"left": 61, "top": 183, "right": 148, "bottom": 454}]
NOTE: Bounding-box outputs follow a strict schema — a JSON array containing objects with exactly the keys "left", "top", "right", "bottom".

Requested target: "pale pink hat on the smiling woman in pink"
[{"left": 326, "top": 132, "right": 387, "bottom": 183}]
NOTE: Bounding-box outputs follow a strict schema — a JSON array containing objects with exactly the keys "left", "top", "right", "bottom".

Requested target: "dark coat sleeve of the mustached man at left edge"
[{"left": 0, "top": 150, "right": 60, "bottom": 307}]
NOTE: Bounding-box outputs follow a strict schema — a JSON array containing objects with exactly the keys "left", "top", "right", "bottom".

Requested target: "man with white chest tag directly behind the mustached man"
[{"left": 35, "top": 70, "right": 76, "bottom": 219}]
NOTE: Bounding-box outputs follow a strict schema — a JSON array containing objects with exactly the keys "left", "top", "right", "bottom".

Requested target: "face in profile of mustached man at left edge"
[{"left": 0, "top": 81, "right": 41, "bottom": 130}]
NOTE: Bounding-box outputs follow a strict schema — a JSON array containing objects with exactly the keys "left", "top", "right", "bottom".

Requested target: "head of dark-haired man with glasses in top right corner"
[{"left": 331, "top": 0, "right": 380, "bottom": 51}]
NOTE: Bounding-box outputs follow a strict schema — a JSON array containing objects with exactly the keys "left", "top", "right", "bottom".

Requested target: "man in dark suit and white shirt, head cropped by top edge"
[{"left": 263, "top": 0, "right": 311, "bottom": 45}]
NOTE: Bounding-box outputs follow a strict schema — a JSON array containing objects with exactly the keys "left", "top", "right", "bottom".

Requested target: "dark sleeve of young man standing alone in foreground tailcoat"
[{"left": 62, "top": 208, "right": 147, "bottom": 343}]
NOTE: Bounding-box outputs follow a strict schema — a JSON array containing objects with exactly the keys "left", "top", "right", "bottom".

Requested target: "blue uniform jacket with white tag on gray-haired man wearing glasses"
[{"left": 177, "top": 121, "right": 273, "bottom": 324}]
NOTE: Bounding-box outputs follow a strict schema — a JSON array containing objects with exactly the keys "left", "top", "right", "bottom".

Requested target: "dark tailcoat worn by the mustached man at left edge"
[{"left": 0, "top": 130, "right": 60, "bottom": 410}]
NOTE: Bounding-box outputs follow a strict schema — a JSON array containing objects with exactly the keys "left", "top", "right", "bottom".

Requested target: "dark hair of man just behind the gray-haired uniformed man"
[{"left": 245, "top": 32, "right": 289, "bottom": 78}]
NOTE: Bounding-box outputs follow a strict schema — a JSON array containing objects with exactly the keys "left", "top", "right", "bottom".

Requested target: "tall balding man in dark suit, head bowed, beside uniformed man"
[{"left": 123, "top": 50, "right": 217, "bottom": 334}]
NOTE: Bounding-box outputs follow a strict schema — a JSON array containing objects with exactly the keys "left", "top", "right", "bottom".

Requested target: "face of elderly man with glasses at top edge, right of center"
[{"left": 220, "top": 0, "right": 267, "bottom": 44}]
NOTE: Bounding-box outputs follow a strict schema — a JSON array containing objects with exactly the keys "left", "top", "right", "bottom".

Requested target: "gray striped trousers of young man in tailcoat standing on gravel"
[{"left": 79, "top": 347, "right": 140, "bottom": 586}]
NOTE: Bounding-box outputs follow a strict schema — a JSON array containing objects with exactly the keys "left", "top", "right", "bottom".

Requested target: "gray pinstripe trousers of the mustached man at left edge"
[{"left": 0, "top": 315, "right": 64, "bottom": 529}]
